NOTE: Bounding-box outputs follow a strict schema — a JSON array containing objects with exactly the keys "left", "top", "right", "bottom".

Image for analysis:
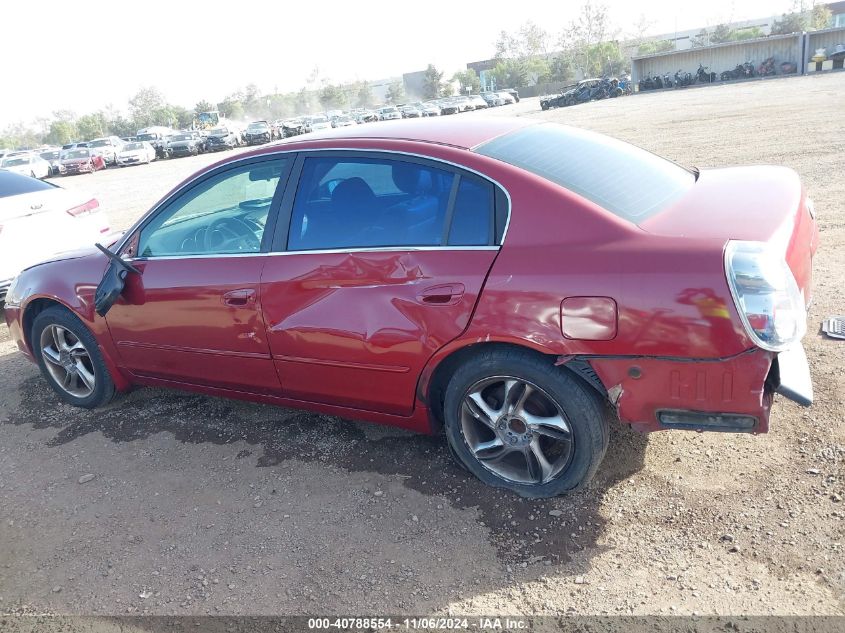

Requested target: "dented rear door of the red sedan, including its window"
[{"left": 261, "top": 152, "right": 503, "bottom": 415}]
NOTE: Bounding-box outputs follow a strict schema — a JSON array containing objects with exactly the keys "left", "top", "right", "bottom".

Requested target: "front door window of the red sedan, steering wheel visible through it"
[{"left": 138, "top": 158, "right": 287, "bottom": 257}]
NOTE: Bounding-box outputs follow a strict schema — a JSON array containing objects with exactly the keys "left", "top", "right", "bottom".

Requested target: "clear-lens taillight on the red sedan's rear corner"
[{"left": 725, "top": 241, "right": 807, "bottom": 352}]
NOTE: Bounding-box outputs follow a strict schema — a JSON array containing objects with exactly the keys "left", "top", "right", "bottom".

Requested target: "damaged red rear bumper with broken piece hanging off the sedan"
[{"left": 589, "top": 344, "right": 813, "bottom": 433}]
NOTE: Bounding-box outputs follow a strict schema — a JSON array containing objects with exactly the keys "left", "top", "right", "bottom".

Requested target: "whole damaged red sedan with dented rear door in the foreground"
[{"left": 5, "top": 118, "right": 818, "bottom": 497}]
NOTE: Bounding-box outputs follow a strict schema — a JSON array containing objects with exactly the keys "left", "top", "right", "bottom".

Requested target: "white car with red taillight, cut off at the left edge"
[{"left": 0, "top": 169, "right": 117, "bottom": 304}]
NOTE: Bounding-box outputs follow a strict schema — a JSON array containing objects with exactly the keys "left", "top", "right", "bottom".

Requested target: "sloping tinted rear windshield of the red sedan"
[{"left": 475, "top": 124, "right": 695, "bottom": 223}]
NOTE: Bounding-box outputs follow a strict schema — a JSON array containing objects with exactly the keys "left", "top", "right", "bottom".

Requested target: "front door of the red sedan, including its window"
[{"left": 106, "top": 158, "right": 289, "bottom": 393}]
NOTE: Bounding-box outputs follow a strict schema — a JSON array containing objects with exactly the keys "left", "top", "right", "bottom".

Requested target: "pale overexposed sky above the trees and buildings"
[{"left": 0, "top": 0, "right": 792, "bottom": 130}]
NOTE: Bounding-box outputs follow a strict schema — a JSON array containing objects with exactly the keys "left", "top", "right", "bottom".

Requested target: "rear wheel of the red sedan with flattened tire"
[{"left": 444, "top": 349, "right": 609, "bottom": 498}]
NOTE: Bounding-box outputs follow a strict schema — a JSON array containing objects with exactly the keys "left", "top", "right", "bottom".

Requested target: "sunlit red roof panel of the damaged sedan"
[{"left": 294, "top": 117, "right": 537, "bottom": 149}]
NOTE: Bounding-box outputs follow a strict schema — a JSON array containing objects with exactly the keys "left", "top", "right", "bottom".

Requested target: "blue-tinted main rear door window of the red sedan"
[{"left": 288, "top": 157, "right": 456, "bottom": 251}]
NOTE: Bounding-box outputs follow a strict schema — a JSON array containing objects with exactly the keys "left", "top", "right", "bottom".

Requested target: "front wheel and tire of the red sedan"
[{"left": 30, "top": 306, "right": 115, "bottom": 409}]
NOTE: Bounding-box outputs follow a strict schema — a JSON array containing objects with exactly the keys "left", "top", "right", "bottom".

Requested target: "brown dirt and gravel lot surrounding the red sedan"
[{"left": 0, "top": 73, "right": 845, "bottom": 614}]
